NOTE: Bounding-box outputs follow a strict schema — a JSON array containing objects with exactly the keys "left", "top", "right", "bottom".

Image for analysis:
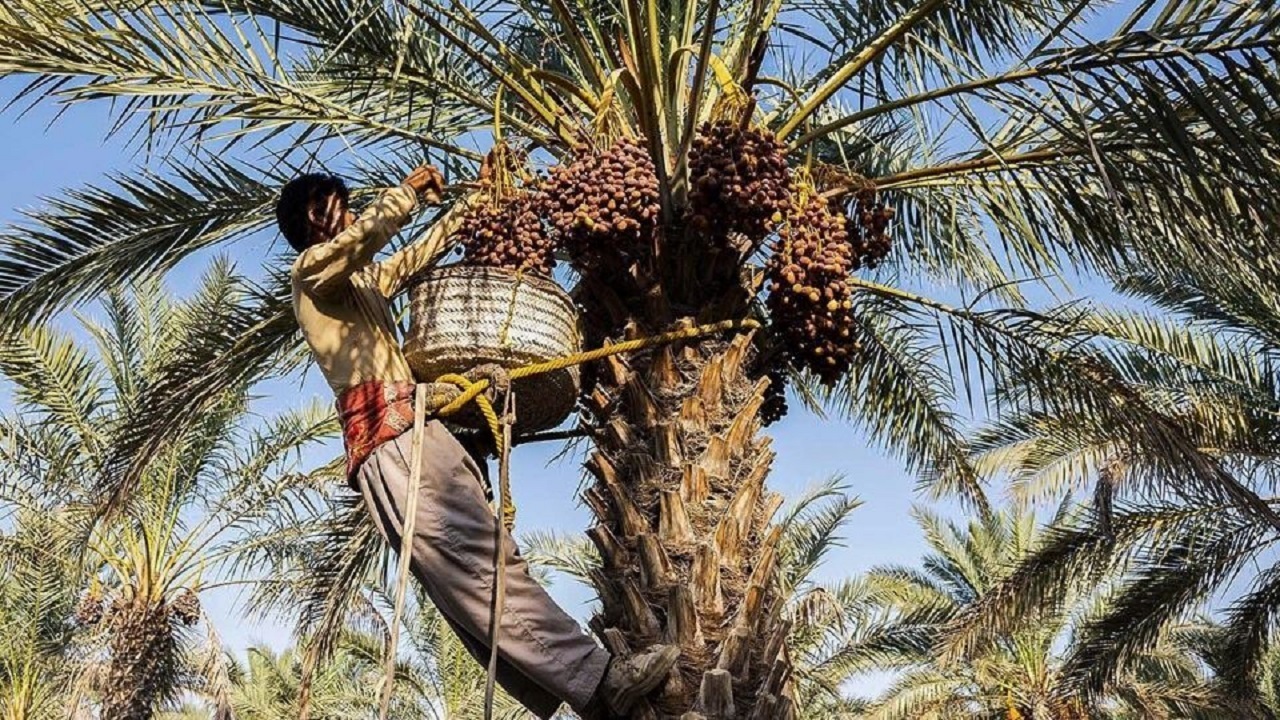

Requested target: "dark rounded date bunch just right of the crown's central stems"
[{"left": 686, "top": 118, "right": 791, "bottom": 247}]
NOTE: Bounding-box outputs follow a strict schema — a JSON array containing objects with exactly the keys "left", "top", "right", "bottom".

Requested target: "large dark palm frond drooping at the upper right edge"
[{"left": 877, "top": 12, "right": 1280, "bottom": 286}]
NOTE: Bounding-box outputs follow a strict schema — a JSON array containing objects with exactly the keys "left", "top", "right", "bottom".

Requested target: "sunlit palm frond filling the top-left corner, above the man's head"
[{"left": 0, "top": 0, "right": 474, "bottom": 156}]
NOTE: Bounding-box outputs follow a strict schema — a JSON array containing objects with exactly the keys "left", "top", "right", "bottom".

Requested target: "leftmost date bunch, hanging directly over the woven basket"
[{"left": 454, "top": 142, "right": 556, "bottom": 277}]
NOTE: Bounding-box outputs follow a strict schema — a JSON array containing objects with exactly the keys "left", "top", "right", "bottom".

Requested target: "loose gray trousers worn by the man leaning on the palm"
[{"left": 356, "top": 421, "right": 609, "bottom": 720}]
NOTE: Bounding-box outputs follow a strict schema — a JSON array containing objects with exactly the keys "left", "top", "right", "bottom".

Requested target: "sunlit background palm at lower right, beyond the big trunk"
[{"left": 844, "top": 506, "right": 1228, "bottom": 720}]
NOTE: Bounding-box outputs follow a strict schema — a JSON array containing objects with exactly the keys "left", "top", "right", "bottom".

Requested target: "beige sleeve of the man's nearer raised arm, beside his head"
[{"left": 293, "top": 186, "right": 417, "bottom": 295}]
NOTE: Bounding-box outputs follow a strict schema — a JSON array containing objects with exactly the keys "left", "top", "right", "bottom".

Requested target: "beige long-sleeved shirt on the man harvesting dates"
[{"left": 289, "top": 186, "right": 465, "bottom": 393}]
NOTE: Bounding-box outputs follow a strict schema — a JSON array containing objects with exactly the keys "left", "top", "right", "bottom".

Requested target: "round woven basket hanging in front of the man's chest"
[{"left": 404, "top": 265, "right": 582, "bottom": 434}]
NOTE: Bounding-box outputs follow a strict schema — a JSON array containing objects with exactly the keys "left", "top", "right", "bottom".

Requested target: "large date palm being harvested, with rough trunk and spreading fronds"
[{"left": 0, "top": 0, "right": 1280, "bottom": 717}]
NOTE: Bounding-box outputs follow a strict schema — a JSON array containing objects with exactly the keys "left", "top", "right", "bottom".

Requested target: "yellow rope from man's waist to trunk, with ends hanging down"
[{"left": 379, "top": 318, "right": 760, "bottom": 720}]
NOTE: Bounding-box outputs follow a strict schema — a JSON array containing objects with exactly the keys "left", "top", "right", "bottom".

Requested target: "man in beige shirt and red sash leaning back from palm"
[{"left": 276, "top": 168, "right": 678, "bottom": 719}]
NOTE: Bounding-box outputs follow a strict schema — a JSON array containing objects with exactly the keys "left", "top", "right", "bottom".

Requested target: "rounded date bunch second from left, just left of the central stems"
[{"left": 539, "top": 137, "right": 662, "bottom": 272}]
